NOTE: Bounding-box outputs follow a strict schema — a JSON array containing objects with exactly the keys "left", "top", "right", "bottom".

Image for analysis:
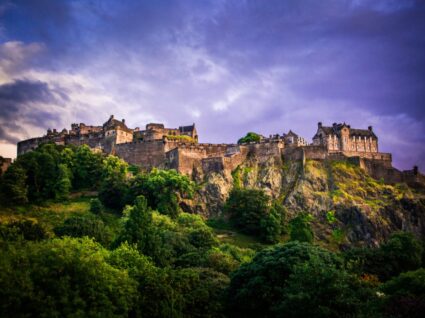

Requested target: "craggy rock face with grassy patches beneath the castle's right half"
[{"left": 193, "top": 156, "right": 425, "bottom": 248}]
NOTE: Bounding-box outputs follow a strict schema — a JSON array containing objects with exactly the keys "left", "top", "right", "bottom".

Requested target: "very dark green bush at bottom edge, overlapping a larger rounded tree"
[{"left": 272, "top": 255, "right": 376, "bottom": 318}]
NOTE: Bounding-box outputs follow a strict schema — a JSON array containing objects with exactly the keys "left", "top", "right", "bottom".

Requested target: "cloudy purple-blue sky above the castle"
[{"left": 0, "top": 0, "right": 425, "bottom": 171}]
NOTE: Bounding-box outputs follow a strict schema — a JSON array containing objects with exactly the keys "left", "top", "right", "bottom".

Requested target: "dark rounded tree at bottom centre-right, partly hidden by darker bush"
[{"left": 227, "top": 241, "right": 342, "bottom": 317}]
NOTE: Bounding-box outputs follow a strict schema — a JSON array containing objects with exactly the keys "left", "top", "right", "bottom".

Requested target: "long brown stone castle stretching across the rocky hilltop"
[{"left": 18, "top": 116, "right": 418, "bottom": 182}]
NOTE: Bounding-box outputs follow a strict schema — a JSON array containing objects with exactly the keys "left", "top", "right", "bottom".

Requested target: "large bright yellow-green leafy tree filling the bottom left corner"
[{"left": 0, "top": 238, "right": 137, "bottom": 317}]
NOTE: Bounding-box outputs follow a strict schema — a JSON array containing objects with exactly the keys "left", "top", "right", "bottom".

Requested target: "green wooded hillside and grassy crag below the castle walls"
[{"left": 0, "top": 144, "right": 425, "bottom": 317}]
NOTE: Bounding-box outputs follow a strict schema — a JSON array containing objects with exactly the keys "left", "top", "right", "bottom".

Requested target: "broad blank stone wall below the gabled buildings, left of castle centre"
[{"left": 114, "top": 140, "right": 166, "bottom": 170}]
